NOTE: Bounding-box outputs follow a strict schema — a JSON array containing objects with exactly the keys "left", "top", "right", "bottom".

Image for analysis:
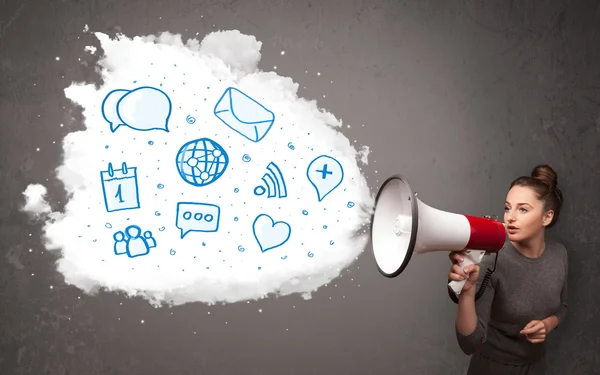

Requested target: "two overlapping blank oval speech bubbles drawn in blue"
[{"left": 102, "top": 86, "right": 172, "bottom": 133}]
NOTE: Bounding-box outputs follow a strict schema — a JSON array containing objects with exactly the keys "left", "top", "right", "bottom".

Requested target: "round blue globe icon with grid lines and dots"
[{"left": 176, "top": 138, "right": 229, "bottom": 186}]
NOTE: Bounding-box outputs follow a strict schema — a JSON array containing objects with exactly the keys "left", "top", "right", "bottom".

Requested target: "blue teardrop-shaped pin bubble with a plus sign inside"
[{"left": 306, "top": 155, "right": 344, "bottom": 202}]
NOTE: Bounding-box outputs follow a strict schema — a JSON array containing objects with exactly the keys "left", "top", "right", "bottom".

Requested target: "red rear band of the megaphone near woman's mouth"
[{"left": 464, "top": 215, "right": 506, "bottom": 252}]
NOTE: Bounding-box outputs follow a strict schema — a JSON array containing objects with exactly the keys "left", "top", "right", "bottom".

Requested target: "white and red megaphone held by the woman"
[{"left": 371, "top": 175, "right": 506, "bottom": 295}]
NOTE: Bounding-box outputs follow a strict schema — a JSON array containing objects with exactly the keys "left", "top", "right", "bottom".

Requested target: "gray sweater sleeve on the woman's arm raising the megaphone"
[{"left": 448, "top": 256, "right": 495, "bottom": 355}]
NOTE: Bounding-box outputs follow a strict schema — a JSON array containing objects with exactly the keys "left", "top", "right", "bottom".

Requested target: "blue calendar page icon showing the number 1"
[{"left": 100, "top": 163, "right": 140, "bottom": 212}]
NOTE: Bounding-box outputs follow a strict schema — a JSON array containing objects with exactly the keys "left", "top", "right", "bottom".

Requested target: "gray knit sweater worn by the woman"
[{"left": 450, "top": 239, "right": 568, "bottom": 365}]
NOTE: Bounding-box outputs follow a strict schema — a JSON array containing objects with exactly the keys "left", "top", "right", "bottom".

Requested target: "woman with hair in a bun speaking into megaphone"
[{"left": 448, "top": 165, "right": 568, "bottom": 375}]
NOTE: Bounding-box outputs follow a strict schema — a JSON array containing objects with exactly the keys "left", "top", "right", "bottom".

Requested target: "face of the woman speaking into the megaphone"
[{"left": 504, "top": 186, "right": 554, "bottom": 242}]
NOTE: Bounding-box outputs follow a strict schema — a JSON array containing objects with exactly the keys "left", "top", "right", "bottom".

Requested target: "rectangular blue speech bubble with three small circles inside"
[{"left": 175, "top": 202, "right": 221, "bottom": 238}]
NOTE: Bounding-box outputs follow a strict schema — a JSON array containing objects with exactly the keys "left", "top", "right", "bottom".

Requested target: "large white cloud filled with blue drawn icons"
[{"left": 26, "top": 31, "right": 373, "bottom": 304}]
